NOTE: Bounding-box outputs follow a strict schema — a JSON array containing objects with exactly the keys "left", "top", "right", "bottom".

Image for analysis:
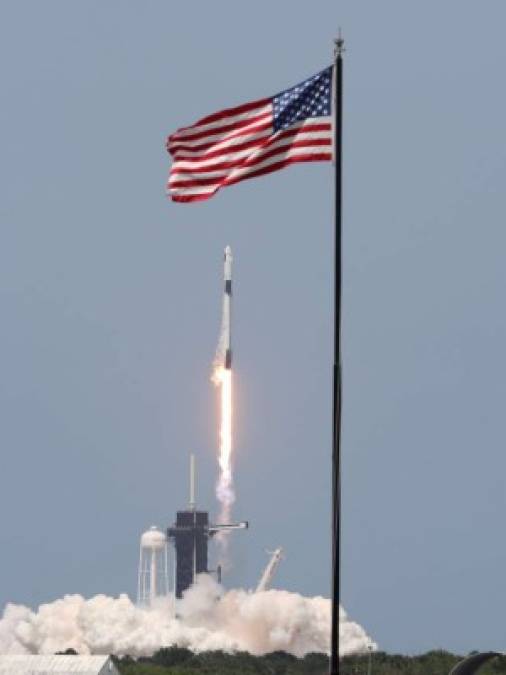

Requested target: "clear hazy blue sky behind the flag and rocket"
[{"left": 0, "top": 0, "right": 506, "bottom": 651}]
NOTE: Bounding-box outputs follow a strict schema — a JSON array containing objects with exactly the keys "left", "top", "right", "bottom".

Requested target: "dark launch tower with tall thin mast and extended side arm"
[{"left": 167, "top": 455, "right": 249, "bottom": 599}]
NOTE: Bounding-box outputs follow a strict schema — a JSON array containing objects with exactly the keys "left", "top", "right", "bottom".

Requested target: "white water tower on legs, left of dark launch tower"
[{"left": 137, "top": 525, "right": 169, "bottom": 605}]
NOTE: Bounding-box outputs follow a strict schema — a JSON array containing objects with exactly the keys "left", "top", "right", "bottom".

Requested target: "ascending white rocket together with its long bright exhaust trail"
[{"left": 211, "top": 246, "right": 235, "bottom": 532}]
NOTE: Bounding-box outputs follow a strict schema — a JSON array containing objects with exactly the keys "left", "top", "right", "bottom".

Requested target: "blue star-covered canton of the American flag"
[{"left": 272, "top": 66, "right": 332, "bottom": 131}]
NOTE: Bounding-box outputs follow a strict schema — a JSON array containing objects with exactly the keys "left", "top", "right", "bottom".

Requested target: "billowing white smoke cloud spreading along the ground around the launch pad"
[{"left": 0, "top": 575, "right": 376, "bottom": 657}]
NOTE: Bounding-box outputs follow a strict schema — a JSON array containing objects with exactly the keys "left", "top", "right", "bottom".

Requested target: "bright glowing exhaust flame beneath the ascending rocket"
[{"left": 212, "top": 365, "right": 235, "bottom": 523}]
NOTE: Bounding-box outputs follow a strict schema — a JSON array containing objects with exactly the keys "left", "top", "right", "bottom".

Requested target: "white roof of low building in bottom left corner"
[{"left": 0, "top": 655, "right": 119, "bottom": 675}]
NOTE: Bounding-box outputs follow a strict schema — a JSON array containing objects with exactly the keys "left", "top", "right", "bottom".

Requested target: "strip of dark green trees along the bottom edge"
[{"left": 111, "top": 647, "right": 506, "bottom": 675}]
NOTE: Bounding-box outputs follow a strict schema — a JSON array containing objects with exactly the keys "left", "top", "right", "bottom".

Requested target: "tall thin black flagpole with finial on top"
[{"left": 330, "top": 31, "right": 344, "bottom": 675}]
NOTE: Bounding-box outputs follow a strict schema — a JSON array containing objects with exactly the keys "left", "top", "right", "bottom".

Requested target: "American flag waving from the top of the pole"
[{"left": 167, "top": 67, "right": 332, "bottom": 202}]
